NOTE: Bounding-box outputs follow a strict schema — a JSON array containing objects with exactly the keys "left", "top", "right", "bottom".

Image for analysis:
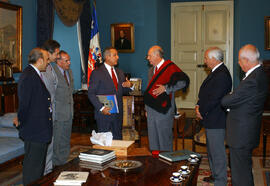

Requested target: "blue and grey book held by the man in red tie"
[{"left": 97, "top": 94, "right": 119, "bottom": 114}]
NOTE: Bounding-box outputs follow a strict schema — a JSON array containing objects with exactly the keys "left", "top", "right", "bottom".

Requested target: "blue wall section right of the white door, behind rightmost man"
[{"left": 234, "top": 0, "right": 270, "bottom": 86}]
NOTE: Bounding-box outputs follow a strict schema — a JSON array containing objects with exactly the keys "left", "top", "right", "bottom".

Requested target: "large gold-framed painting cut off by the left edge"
[{"left": 0, "top": 2, "right": 22, "bottom": 72}]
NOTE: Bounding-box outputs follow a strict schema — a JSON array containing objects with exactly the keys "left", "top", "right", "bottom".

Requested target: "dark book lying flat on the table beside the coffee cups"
[{"left": 159, "top": 149, "right": 201, "bottom": 162}]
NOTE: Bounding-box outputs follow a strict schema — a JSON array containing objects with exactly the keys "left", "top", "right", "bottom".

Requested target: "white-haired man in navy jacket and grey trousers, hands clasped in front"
[{"left": 195, "top": 47, "right": 232, "bottom": 186}]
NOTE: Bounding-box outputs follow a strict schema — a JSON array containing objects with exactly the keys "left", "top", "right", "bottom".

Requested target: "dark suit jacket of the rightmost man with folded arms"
[{"left": 221, "top": 66, "right": 268, "bottom": 148}]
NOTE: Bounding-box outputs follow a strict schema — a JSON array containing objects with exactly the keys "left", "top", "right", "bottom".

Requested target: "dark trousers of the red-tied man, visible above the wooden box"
[{"left": 96, "top": 114, "right": 123, "bottom": 140}]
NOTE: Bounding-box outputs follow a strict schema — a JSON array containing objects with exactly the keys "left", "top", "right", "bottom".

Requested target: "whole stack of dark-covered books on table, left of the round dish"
[{"left": 79, "top": 149, "right": 115, "bottom": 169}]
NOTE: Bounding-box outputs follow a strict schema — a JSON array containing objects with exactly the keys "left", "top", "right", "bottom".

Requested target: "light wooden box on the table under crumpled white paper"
[{"left": 93, "top": 140, "right": 134, "bottom": 156}]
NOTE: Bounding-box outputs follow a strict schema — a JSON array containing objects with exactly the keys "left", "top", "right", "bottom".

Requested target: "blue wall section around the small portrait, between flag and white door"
[{"left": 96, "top": 0, "right": 171, "bottom": 89}]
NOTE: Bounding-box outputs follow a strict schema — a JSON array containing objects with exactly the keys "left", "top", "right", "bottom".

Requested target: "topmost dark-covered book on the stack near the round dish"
[{"left": 80, "top": 149, "right": 115, "bottom": 160}]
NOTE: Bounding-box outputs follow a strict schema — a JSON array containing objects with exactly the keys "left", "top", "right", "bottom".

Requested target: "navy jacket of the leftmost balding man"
[{"left": 18, "top": 65, "right": 52, "bottom": 143}]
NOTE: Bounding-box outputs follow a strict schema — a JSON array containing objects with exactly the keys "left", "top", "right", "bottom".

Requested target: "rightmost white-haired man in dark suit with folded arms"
[{"left": 221, "top": 44, "right": 268, "bottom": 186}]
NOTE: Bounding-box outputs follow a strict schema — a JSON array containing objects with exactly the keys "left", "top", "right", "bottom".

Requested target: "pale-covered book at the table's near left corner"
[{"left": 54, "top": 171, "right": 89, "bottom": 185}]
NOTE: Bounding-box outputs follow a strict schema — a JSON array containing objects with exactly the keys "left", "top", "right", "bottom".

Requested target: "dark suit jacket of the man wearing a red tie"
[{"left": 88, "top": 64, "right": 131, "bottom": 118}]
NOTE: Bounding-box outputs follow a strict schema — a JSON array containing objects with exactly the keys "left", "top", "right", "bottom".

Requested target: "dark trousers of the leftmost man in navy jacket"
[{"left": 23, "top": 141, "right": 48, "bottom": 185}]
